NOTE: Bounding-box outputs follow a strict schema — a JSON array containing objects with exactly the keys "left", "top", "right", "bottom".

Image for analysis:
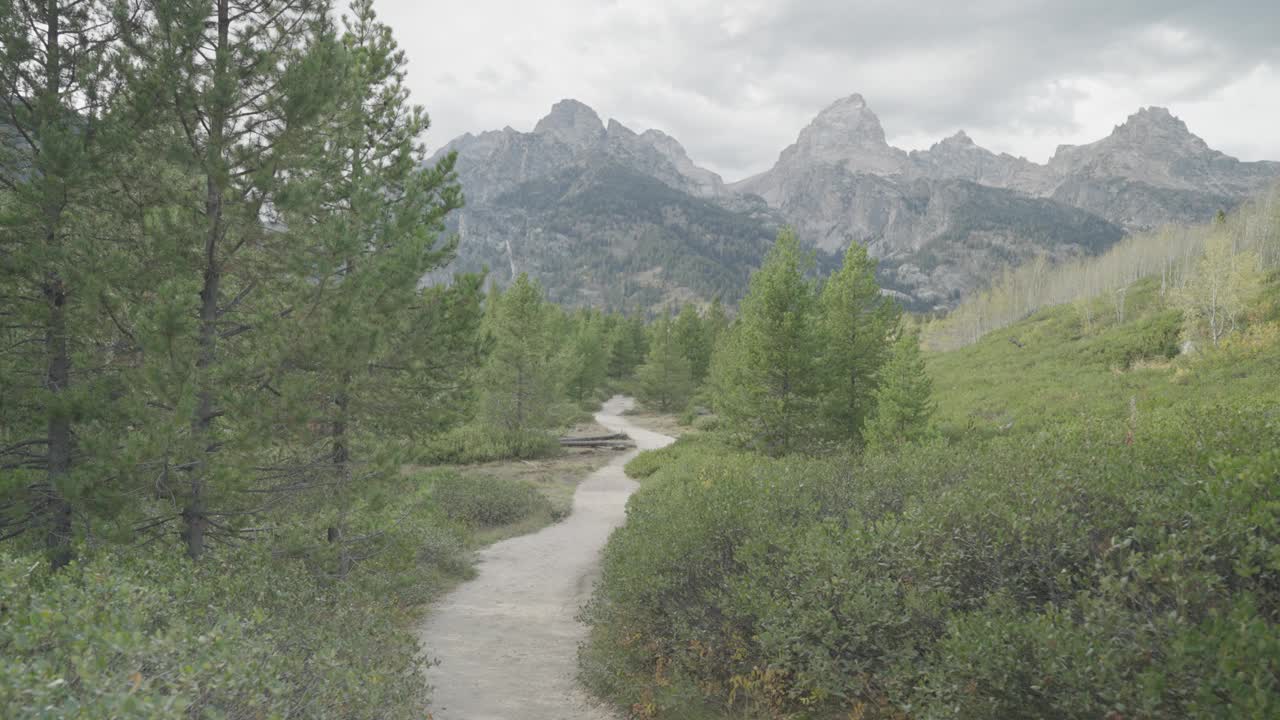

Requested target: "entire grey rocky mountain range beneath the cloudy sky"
[{"left": 433, "top": 95, "right": 1280, "bottom": 310}]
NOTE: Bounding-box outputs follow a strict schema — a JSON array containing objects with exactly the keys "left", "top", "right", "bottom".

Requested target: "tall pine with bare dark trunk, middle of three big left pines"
[{"left": 125, "top": 0, "right": 346, "bottom": 559}]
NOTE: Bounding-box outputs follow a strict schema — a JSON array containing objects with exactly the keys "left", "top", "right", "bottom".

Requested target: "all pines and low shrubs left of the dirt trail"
[{"left": 0, "top": 0, "right": 646, "bottom": 719}]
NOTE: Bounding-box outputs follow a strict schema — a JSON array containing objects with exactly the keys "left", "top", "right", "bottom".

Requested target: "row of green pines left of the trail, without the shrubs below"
[{"left": 0, "top": 0, "right": 648, "bottom": 574}]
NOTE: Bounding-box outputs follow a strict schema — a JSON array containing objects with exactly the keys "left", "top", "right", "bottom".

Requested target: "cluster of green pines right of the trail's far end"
[{"left": 637, "top": 229, "right": 932, "bottom": 456}]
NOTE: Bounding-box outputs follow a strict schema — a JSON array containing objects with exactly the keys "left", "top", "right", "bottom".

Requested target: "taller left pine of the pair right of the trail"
[{"left": 712, "top": 229, "right": 822, "bottom": 455}]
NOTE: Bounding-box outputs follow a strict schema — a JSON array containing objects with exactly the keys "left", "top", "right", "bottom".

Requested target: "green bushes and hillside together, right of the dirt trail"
[{"left": 581, "top": 203, "right": 1280, "bottom": 719}]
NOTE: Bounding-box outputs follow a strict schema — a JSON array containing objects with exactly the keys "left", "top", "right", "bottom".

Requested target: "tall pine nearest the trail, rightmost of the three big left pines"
[{"left": 267, "top": 0, "right": 468, "bottom": 574}]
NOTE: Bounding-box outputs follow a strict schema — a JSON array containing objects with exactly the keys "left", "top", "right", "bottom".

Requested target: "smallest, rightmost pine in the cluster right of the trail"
[{"left": 864, "top": 332, "right": 934, "bottom": 448}]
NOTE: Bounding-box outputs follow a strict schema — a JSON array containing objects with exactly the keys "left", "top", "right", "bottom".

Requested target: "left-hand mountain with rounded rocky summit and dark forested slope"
[{"left": 436, "top": 100, "right": 782, "bottom": 309}]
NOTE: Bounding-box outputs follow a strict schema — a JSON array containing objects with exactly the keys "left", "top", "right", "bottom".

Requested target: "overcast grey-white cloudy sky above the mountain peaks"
[{"left": 375, "top": 0, "right": 1280, "bottom": 181}]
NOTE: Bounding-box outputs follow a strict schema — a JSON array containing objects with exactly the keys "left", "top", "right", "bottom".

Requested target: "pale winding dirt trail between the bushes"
[{"left": 419, "top": 396, "right": 672, "bottom": 720}]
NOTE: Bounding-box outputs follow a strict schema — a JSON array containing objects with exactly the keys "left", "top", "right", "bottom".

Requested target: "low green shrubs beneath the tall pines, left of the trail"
[{"left": 0, "top": 476, "right": 470, "bottom": 720}]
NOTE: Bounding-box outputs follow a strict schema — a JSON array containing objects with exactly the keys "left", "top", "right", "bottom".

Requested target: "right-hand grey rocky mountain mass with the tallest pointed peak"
[{"left": 730, "top": 95, "right": 1280, "bottom": 309}]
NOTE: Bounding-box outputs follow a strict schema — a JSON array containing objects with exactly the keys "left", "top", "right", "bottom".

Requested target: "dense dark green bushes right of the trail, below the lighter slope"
[{"left": 581, "top": 407, "right": 1280, "bottom": 719}]
